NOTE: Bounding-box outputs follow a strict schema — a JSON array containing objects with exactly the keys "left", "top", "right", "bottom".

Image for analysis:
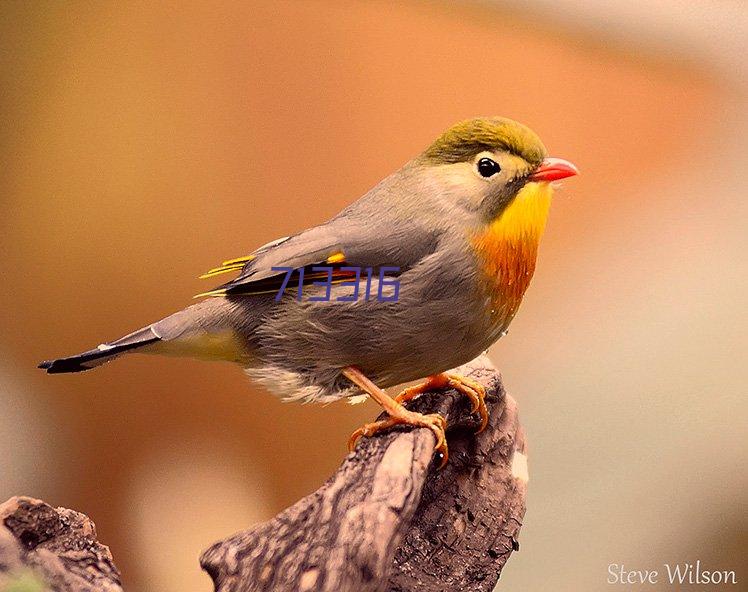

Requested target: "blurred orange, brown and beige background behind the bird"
[{"left": 0, "top": 0, "right": 748, "bottom": 592}]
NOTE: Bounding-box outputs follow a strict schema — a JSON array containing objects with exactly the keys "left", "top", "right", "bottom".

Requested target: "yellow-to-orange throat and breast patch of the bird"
[{"left": 472, "top": 183, "right": 553, "bottom": 325}]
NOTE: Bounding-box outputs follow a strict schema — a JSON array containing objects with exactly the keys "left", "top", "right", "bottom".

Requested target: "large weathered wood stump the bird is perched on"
[{"left": 200, "top": 356, "right": 527, "bottom": 592}]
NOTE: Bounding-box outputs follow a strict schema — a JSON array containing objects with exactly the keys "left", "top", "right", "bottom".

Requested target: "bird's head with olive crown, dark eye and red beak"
[{"left": 417, "top": 117, "right": 578, "bottom": 219}]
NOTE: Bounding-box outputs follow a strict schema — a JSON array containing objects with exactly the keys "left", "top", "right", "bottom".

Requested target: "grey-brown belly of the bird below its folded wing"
[{"left": 243, "top": 270, "right": 516, "bottom": 401}]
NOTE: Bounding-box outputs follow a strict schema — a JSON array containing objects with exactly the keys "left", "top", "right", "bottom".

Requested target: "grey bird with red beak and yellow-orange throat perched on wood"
[{"left": 39, "top": 117, "right": 577, "bottom": 462}]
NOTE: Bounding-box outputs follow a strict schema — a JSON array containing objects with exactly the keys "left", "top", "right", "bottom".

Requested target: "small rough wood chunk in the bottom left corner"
[{"left": 0, "top": 497, "right": 122, "bottom": 592}]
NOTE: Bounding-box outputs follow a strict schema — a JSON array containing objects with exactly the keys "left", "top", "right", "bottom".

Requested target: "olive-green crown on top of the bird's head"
[{"left": 423, "top": 117, "right": 547, "bottom": 165}]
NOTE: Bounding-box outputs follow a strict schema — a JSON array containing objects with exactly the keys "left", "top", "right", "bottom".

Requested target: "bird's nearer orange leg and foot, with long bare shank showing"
[{"left": 342, "top": 366, "right": 449, "bottom": 467}]
